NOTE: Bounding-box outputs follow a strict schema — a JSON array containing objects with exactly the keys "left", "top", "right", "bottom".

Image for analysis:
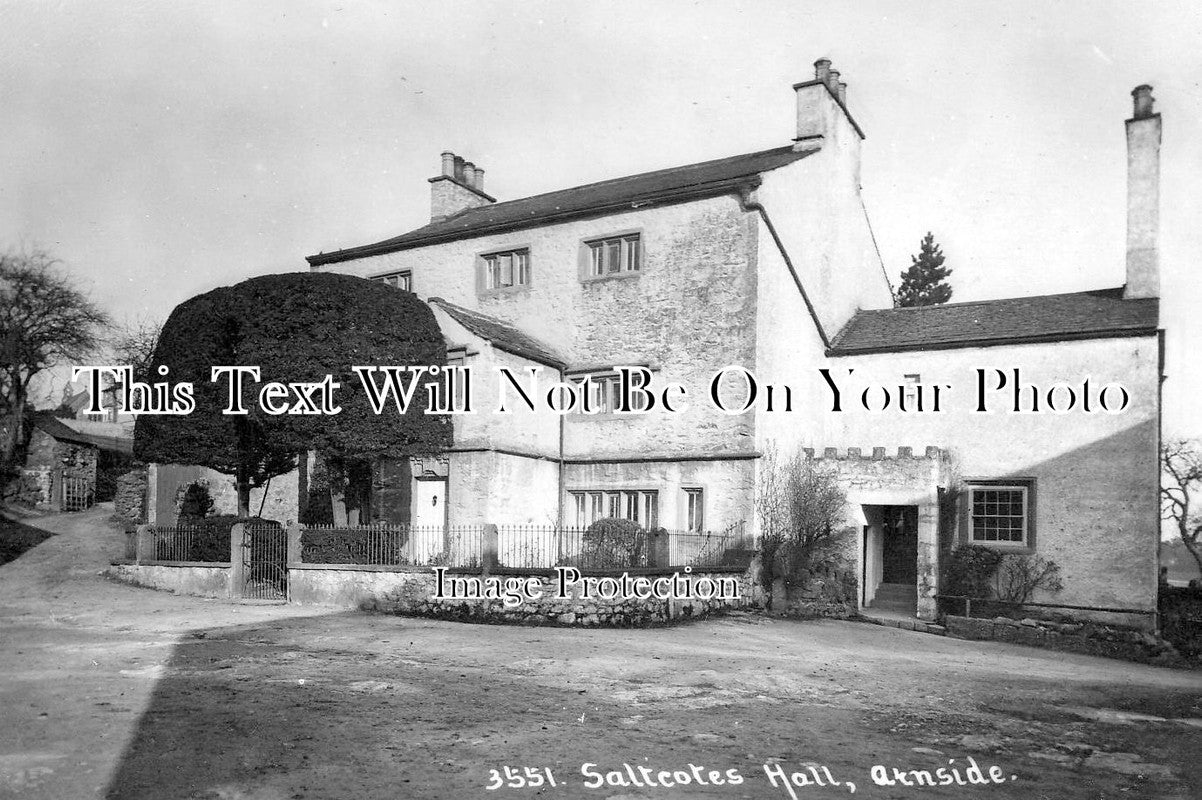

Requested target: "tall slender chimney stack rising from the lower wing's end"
[{"left": 1123, "top": 84, "right": 1160, "bottom": 300}]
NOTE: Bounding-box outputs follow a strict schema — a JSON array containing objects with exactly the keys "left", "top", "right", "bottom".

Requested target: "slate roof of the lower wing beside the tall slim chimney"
[{"left": 829, "top": 288, "right": 1159, "bottom": 356}]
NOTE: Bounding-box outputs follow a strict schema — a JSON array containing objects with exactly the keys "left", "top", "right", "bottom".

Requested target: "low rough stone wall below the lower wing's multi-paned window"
[{"left": 944, "top": 615, "right": 1182, "bottom": 665}]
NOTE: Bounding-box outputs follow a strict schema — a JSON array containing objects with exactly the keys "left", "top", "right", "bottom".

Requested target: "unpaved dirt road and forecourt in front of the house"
[{"left": 0, "top": 511, "right": 1202, "bottom": 800}]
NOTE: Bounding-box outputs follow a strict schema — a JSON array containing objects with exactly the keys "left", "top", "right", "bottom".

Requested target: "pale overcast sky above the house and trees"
[{"left": 0, "top": 0, "right": 1202, "bottom": 435}]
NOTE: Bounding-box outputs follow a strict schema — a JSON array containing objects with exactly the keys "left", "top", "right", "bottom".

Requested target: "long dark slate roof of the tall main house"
[{"left": 307, "top": 145, "right": 815, "bottom": 267}]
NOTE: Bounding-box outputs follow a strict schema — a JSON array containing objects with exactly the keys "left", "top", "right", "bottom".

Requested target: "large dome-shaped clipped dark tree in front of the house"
[{"left": 135, "top": 273, "right": 451, "bottom": 515}]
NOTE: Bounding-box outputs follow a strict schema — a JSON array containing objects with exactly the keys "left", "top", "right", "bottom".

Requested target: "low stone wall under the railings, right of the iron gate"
[{"left": 288, "top": 565, "right": 758, "bottom": 627}]
